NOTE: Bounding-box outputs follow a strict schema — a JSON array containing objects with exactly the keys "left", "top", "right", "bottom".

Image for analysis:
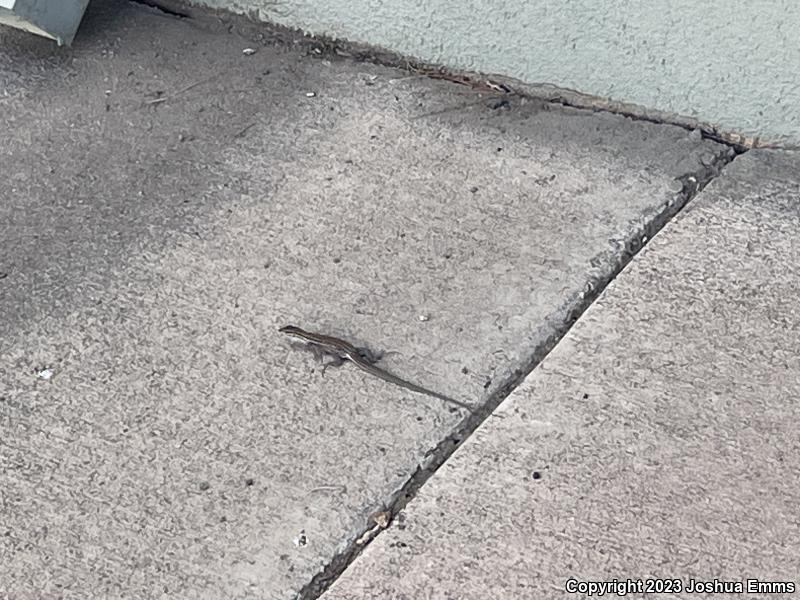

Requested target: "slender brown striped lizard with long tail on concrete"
[{"left": 278, "top": 325, "right": 473, "bottom": 412}]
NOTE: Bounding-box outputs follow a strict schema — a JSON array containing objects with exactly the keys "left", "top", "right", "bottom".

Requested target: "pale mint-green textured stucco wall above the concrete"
[{"left": 197, "top": 0, "right": 800, "bottom": 144}]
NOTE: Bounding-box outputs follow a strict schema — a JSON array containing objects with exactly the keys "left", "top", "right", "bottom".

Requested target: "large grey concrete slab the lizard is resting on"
[{"left": 0, "top": 2, "right": 727, "bottom": 598}]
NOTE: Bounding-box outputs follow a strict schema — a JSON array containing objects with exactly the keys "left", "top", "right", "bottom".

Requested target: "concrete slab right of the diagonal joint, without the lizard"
[{"left": 323, "top": 152, "right": 800, "bottom": 600}]
